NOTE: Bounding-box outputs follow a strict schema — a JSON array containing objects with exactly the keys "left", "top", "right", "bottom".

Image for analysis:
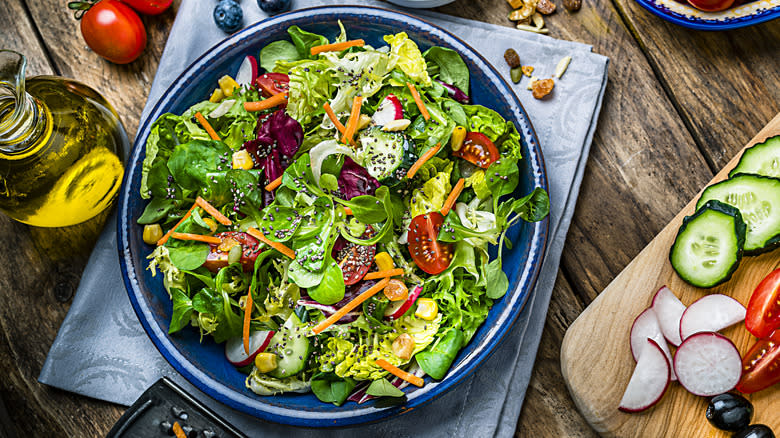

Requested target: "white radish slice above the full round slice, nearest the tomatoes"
[{"left": 680, "top": 294, "right": 747, "bottom": 340}]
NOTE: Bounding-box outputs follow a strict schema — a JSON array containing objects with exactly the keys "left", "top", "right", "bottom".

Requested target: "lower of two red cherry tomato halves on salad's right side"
[{"left": 407, "top": 211, "right": 454, "bottom": 275}]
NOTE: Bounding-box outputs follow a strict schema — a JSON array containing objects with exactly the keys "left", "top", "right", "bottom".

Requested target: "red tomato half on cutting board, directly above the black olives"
[{"left": 737, "top": 330, "right": 780, "bottom": 394}]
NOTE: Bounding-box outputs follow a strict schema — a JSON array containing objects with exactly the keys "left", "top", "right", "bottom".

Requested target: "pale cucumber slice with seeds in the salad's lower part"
[{"left": 267, "top": 313, "right": 311, "bottom": 379}]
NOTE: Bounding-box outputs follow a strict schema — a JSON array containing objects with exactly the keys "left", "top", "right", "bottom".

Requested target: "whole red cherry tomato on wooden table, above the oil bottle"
[{"left": 81, "top": 0, "right": 146, "bottom": 64}]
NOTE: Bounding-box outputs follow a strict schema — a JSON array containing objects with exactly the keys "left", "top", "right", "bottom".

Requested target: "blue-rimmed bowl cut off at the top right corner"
[{"left": 636, "top": 0, "right": 780, "bottom": 30}]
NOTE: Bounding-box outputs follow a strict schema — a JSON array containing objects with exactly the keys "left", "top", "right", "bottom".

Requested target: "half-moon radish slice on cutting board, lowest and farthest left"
[{"left": 618, "top": 339, "right": 672, "bottom": 412}]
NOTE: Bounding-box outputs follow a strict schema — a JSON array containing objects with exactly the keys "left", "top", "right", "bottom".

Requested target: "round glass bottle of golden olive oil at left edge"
[{"left": 0, "top": 51, "right": 127, "bottom": 227}]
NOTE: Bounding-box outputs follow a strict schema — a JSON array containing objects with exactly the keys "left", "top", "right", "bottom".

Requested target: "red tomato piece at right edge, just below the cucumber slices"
[{"left": 745, "top": 268, "right": 780, "bottom": 338}]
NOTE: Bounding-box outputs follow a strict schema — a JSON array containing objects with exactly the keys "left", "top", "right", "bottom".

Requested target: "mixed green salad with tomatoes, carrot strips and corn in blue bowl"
[{"left": 138, "top": 23, "right": 549, "bottom": 405}]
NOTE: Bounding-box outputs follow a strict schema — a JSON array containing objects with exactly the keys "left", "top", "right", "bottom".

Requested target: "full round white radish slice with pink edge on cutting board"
[{"left": 674, "top": 333, "right": 742, "bottom": 397}]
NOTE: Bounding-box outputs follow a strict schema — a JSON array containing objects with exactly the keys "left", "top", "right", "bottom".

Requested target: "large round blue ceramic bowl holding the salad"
[{"left": 117, "top": 7, "right": 548, "bottom": 427}]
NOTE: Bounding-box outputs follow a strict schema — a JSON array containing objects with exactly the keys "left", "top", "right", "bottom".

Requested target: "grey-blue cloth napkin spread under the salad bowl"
[{"left": 39, "top": 0, "right": 608, "bottom": 438}]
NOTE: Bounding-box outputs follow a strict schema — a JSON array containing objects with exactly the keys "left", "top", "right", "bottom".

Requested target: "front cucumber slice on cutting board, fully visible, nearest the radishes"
[{"left": 669, "top": 199, "right": 746, "bottom": 287}]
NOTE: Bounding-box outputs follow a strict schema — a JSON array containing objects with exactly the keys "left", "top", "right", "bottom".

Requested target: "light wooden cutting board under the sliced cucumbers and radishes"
[{"left": 561, "top": 114, "right": 780, "bottom": 438}]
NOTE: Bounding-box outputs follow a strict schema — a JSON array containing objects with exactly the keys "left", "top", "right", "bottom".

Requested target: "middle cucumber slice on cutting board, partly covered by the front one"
[{"left": 696, "top": 173, "right": 780, "bottom": 255}]
